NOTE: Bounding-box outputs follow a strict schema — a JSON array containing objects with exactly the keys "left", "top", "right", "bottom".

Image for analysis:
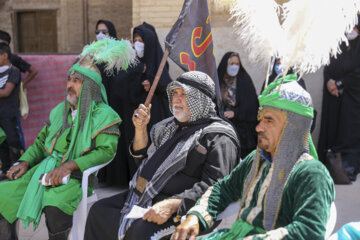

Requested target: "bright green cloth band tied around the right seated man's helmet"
[{"left": 259, "top": 74, "right": 319, "bottom": 159}]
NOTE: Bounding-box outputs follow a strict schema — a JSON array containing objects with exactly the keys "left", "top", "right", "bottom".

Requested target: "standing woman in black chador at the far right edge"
[{"left": 318, "top": 17, "right": 360, "bottom": 182}]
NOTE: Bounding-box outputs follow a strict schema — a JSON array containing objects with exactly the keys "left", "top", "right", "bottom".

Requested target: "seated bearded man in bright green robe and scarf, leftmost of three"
[{"left": 0, "top": 58, "right": 121, "bottom": 240}]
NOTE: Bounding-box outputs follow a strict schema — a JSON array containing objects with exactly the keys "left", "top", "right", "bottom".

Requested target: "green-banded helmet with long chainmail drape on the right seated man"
[{"left": 242, "top": 74, "right": 317, "bottom": 231}]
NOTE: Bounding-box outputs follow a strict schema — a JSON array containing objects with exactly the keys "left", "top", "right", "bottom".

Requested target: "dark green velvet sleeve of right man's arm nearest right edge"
[{"left": 252, "top": 160, "right": 335, "bottom": 240}]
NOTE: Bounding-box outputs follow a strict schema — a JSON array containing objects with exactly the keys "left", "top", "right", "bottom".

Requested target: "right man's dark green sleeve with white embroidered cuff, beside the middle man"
[{"left": 187, "top": 151, "right": 255, "bottom": 230}]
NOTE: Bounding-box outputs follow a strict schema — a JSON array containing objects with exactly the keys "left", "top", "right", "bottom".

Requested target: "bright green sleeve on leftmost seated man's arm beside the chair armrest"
[{"left": 74, "top": 133, "right": 119, "bottom": 172}]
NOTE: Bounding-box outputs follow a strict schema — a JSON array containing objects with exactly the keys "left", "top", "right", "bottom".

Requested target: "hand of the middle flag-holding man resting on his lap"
[{"left": 143, "top": 199, "right": 181, "bottom": 225}]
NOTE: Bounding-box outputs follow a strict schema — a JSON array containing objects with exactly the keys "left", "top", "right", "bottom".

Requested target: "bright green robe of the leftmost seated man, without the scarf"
[{"left": 0, "top": 102, "right": 121, "bottom": 223}]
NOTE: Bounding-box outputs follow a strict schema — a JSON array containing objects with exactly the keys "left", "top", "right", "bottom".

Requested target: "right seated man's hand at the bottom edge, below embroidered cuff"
[{"left": 171, "top": 215, "right": 200, "bottom": 240}]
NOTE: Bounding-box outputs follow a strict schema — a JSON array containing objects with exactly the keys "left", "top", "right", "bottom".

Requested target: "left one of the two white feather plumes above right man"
[{"left": 230, "top": 0, "right": 284, "bottom": 67}]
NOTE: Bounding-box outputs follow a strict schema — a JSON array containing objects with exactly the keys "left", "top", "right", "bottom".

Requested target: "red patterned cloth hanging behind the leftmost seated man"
[{"left": 20, "top": 55, "right": 77, "bottom": 148}]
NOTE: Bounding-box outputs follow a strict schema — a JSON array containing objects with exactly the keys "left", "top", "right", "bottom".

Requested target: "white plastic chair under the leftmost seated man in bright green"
[{"left": 68, "top": 159, "right": 112, "bottom": 240}]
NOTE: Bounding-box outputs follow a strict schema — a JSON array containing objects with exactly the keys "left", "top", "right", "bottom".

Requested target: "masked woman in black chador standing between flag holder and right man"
[{"left": 218, "top": 52, "right": 259, "bottom": 158}]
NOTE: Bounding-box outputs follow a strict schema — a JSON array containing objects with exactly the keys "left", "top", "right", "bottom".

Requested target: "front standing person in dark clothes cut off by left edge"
[{"left": 0, "top": 43, "right": 23, "bottom": 180}]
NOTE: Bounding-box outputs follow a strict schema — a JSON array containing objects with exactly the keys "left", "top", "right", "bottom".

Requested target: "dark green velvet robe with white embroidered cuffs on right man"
[{"left": 188, "top": 151, "right": 335, "bottom": 240}]
